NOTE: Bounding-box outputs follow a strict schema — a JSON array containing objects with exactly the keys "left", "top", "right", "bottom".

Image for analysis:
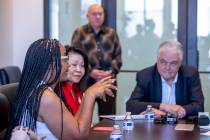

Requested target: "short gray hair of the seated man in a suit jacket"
[{"left": 157, "top": 40, "right": 184, "bottom": 61}]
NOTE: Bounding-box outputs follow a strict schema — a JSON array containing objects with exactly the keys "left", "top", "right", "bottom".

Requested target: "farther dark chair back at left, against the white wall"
[{"left": 0, "top": 66, "right": 21, "bottom": 85}]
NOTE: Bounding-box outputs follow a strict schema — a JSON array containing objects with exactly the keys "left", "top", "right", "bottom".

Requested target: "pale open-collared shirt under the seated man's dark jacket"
[{"left": 161, "top": 73, "right": 178, "bottom": 104}]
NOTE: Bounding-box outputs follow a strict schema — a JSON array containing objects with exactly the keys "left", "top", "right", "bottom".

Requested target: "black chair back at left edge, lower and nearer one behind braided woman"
[{"left": 0, "top": 83, "right": 18, "bottom": 132}]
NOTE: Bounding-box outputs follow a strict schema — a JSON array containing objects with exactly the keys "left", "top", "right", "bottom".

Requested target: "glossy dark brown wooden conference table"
[{"left": 88, "top": 119, "right": 210, "bottom": 140}]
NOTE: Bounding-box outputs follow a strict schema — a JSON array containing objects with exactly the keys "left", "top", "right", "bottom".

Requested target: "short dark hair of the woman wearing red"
[{"left": 65, "top": 45, "right": 89, "bottom": 83}]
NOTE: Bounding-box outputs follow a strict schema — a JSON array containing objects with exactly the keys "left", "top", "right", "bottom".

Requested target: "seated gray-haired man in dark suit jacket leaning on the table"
[{"left": 126, "top": 40, "right": 204, "bottom": 118}]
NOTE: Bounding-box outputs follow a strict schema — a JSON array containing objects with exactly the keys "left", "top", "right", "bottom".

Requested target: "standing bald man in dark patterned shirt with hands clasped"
[{"left": 72, "top": 4, "right": 122, "bottom": 118}]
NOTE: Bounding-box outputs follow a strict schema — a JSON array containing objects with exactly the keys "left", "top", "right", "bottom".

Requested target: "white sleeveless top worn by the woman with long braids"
[{"left": 36, "top": 121, "right": 58, "bottom": 140}]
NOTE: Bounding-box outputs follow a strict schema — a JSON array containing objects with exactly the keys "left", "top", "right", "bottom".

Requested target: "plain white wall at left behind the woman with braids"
[{"left": 0, "top": 0, "right": 44, "bottom": 69}]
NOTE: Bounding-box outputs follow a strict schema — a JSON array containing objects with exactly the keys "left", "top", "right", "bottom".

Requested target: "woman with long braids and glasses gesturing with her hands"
[{"left": 7, "top": 39, "right": 116, "bottom": 140}]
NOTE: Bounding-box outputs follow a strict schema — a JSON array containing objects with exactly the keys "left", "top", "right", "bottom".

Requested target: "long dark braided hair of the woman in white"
[{"left": 7, "top": 39, "right": 61, "bottom": 139}]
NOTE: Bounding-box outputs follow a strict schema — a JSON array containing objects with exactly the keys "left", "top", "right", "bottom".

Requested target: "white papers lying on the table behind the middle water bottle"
[{"left": 99, "top": 115, "right": 145, "bottom": 121}]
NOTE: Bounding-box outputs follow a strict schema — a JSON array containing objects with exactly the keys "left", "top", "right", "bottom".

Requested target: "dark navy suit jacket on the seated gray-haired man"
[{"left": 126, "top": 65, "right": 204, "bottom": 116}]
